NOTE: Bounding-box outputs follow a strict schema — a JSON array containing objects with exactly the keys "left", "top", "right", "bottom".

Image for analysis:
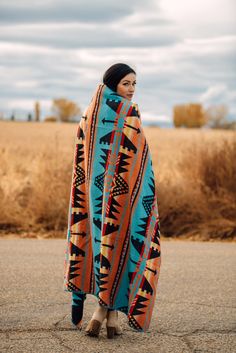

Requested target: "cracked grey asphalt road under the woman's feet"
[{"left": 0, "top": 239, "right": 236, "bottom": 353}]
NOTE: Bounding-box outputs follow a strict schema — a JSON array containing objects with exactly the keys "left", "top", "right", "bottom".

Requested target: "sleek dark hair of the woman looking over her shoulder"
[{"left": 103, "top": 63, "right": 136, "bottom": 92}]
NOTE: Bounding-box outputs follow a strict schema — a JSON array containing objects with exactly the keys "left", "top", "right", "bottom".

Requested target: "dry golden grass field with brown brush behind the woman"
[{"left": 0, "top": 121, "right": 236, "bottom": 240}]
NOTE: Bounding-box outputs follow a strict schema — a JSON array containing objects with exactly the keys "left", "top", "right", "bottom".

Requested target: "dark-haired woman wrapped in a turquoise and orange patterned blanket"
[{"left": 64, "top": 63, "right": 161, "bottom": 338}]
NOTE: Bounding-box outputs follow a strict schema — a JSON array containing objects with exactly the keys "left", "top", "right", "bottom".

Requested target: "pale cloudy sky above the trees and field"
[{"left": 0, "top": 0, "right": 236, "bottom": 121}]
